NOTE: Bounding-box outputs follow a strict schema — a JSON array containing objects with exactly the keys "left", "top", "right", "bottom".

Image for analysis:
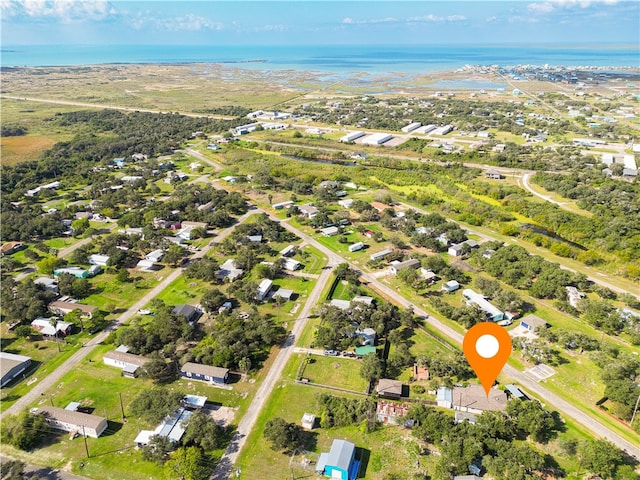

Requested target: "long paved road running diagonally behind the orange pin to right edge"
[{"left": 270, "top": 215, "right": 640, "bottom": 460}]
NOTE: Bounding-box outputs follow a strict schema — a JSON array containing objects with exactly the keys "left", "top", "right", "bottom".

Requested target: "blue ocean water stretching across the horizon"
[{"left": 0, "top": 45, "right": 640, "bottom": 73}]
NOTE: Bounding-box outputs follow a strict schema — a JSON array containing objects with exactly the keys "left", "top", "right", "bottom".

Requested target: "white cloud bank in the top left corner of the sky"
[{"left": 1, "top": 0, "right": 118, "bottom": 21}]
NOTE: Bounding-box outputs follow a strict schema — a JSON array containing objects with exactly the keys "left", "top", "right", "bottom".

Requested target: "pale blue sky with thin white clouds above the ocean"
[{"left": 0, "top": 0, "right": 640, "bottom": 46}]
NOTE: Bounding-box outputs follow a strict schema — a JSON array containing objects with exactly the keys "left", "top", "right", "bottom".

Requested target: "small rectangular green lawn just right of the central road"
[{"left": 302, "top": 355, "right": 367, "bottom": 393}]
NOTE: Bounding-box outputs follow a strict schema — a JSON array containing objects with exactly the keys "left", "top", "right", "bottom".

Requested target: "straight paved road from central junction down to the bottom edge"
[{"left": 211, "top": 260, "right": 336, "bottom": 480}]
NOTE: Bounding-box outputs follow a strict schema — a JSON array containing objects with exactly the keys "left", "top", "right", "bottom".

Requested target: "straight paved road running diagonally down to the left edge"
[{"left": 0, "top": 211, "right": 256, "bottom": 418}]
